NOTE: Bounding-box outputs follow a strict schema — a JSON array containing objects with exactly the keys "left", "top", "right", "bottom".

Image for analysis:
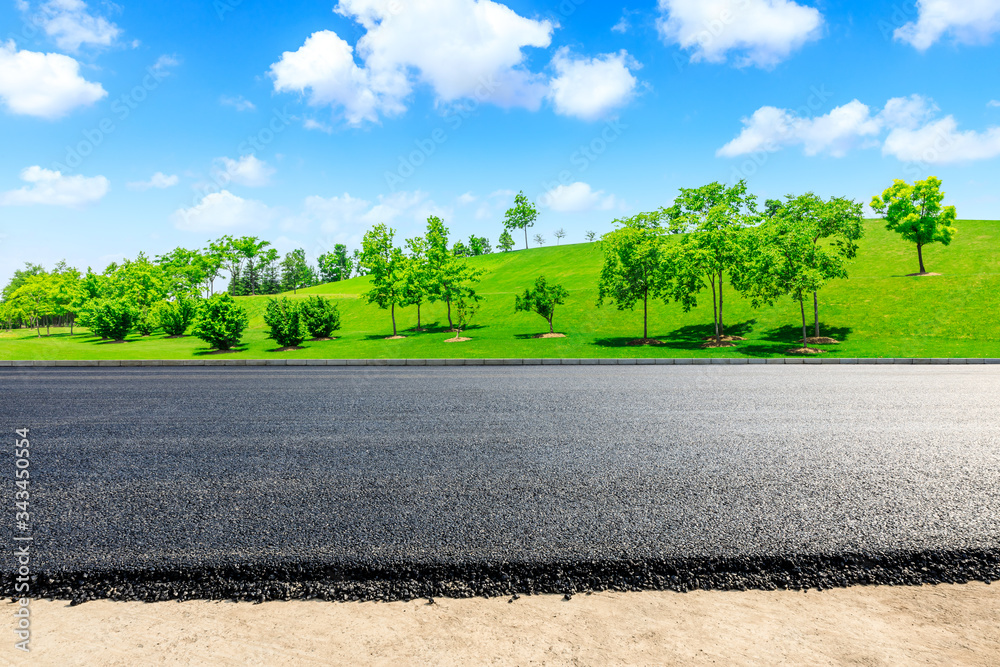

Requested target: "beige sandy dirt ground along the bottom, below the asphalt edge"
[{"left": 0, "top": 584, "right": 1000, "bottom": 666}]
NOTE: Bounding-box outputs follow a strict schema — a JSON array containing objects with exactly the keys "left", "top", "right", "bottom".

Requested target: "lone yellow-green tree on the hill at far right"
[{"left": 872, "top": 176, "right": 957, "bottom": 276}]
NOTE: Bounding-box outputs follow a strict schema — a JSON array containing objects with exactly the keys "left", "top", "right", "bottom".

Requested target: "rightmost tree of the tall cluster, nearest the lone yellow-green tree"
[{"left": 769, "top": 192, "right": 865, "bottom": 338}]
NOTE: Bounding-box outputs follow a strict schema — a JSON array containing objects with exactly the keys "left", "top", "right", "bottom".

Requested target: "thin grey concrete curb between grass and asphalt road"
[{"left": 0, "top": 357, "right": 1000, "bottom": 368}]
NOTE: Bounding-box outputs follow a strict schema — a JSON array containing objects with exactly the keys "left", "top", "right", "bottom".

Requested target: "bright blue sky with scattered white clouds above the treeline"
[{"left": 0, "top": 0, "right": 1000, "bottom": 281}]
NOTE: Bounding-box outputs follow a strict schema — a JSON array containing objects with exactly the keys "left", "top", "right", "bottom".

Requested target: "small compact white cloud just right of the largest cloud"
[{"left": 549, "top": 48, "right": 637, "bottom": 120}]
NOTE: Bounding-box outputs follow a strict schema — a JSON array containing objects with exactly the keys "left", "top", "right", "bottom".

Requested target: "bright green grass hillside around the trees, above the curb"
[{"left": 0, "top": 221, "right": 1000, "bottom": 360}]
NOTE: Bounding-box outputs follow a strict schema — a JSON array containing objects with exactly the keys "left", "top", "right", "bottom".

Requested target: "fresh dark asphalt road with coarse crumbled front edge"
[{"left": 0, "top": 366, "right": 1000, "bottom": 602}]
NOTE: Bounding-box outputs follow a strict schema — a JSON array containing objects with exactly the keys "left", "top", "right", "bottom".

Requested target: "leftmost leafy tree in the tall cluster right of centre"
[{"left": 597, "top": 212, "right": 663, "bottom": 345}]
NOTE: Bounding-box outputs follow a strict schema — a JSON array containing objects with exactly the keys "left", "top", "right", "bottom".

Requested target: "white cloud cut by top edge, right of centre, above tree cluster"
[{"left": 657, "top": 0, "right": 823, "bottom": 67}]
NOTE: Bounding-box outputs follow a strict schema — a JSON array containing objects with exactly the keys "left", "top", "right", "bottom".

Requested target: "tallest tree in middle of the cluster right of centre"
[{"left": 662, "top": 181, "right": 760, "bottom": 345}]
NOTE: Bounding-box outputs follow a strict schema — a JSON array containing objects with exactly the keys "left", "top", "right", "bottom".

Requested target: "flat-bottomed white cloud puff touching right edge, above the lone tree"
[{"left": 882, "top": 116, "right": 1000, "bottom": 164}]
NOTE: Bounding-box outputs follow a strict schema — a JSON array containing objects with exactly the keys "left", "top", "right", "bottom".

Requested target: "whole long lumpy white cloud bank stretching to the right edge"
[{"left": 717, "top": 95, "right": 1000, "bottom": 164}]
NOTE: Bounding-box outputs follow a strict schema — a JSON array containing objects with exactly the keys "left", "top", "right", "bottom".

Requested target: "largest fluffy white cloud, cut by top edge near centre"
[{"left": 270, "top": 0, "right": 553, "bottom": 125}]
